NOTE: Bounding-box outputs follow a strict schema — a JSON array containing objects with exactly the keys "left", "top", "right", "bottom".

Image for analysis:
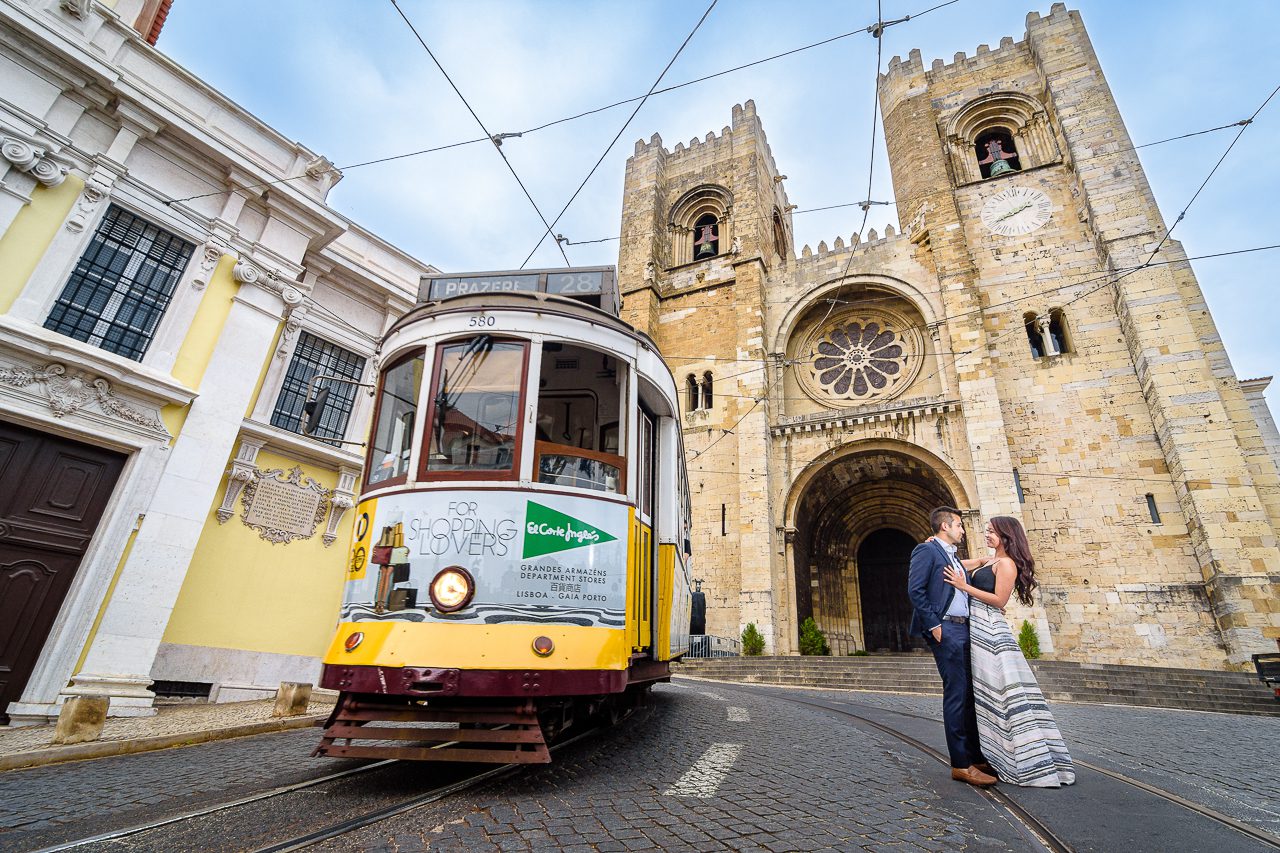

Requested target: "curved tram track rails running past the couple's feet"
[{"left": 717, "top": 681, "right": 1280, "bottom": 853}]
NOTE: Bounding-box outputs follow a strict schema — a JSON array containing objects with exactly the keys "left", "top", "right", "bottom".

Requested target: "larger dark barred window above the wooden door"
[{"left": 45, "top": 205, "right": 195, "bottom": 361}]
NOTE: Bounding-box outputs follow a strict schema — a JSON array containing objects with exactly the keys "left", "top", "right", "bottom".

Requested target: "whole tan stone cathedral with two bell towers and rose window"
[{"left": 618, "top": 4, "right": 1280, "bottom": 669}]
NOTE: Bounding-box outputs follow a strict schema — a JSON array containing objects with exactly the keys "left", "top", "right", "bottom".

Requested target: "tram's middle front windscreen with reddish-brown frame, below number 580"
[{"left": 422, "top": 336, "right": 527, "bottom": 476}]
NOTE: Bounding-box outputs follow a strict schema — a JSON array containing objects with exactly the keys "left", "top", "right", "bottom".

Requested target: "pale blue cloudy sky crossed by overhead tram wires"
[{"left": 157, "top": 0, "right": 1280, "bottom": 416}]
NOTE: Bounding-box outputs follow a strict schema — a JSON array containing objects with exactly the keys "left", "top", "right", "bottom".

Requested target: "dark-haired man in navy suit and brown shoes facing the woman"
[{"left": 906, "top": 506, "right": 997, "bottom": 788}]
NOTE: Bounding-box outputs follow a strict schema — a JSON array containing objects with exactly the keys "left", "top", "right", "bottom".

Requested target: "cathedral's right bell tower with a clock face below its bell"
[{"left": 881, "top": 4, "right": 1280, "bottom": 666}]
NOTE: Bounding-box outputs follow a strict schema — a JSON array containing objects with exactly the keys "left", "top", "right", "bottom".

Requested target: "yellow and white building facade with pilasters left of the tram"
[{"left": 0, "top": 0, "right": 435, "bottom": 724}]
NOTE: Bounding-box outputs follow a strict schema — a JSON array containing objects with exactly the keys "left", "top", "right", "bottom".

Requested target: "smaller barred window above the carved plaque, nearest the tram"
[{"left": 271, "top": 332, "right": 365, "bottom": 439}]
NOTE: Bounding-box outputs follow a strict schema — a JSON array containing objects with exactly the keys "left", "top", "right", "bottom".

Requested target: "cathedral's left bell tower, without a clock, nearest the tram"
[{"left": 618, "top": 101, "right": 792, "bottom": 646}]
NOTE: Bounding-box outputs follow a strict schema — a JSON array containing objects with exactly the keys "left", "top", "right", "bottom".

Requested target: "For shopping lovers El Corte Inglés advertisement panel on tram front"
[{"left": 342, "top": 491, "right": 630, "bottom": 628}]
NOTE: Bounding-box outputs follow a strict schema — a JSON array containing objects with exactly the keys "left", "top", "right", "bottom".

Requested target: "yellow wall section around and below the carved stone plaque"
[{"left": 164, "top": 451, "right": 355, "bottom": 657}]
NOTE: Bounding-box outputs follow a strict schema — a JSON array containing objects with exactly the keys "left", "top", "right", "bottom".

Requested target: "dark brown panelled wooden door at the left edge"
[{"left": 0, "top": 421, "right": 125, "bottom": 722}]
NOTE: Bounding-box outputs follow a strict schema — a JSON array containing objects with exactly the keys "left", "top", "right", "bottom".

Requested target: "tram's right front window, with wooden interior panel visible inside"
[{"left": 534, "top": 341, "right": 626, "bottom": 492}]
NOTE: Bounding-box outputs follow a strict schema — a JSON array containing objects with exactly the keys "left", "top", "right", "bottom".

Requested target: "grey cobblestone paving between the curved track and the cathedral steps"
[{"left": 768, "top": 690, "right": 1280, "bottom": 838}]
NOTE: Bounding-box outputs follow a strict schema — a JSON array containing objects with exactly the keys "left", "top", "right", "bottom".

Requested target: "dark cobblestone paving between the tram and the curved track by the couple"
[{"left": 315, "top": 686, "right": 1024, "bottom": 853}]
